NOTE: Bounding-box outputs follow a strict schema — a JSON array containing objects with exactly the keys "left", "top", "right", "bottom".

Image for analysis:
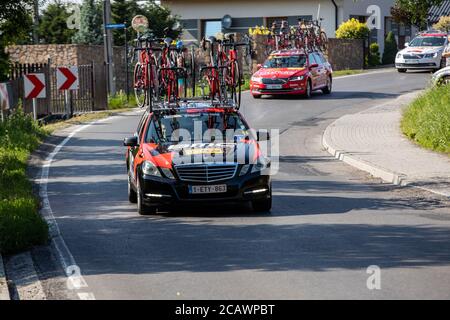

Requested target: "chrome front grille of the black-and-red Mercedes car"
[{"left": 175, "top": 164, "right": 237, "bottom": 182}]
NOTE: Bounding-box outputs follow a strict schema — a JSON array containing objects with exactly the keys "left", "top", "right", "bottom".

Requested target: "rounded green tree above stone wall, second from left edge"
[{"left": 39, "top": 1, "right": 76, "bottom": 44}]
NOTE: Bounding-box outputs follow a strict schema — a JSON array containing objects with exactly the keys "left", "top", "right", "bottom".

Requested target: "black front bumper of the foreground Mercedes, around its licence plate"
[{"left": 140, "top": 173, "right": 271, "bottom": 206}]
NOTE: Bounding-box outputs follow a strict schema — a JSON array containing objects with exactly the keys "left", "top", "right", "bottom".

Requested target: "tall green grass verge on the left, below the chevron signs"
[{"left": 0, "top": 110, "right": 48, "bottom": 253}]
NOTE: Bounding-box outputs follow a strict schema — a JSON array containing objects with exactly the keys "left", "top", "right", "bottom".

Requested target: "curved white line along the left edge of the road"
[{"left": 39, "top": 116, "right": 121, "bottom": 300}]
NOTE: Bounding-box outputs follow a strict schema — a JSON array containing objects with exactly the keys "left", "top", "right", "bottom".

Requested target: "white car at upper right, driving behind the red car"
[{"left": 395, "top": 33, "right": 448, "bottom": 72}]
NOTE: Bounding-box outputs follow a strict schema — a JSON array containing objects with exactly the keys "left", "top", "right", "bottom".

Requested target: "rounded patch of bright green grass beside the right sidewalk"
[{"left": 401, "top": 85, "right": 450, "bottom": 155}]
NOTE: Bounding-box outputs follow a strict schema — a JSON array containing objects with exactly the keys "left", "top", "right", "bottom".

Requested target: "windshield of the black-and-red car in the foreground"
[{"left": 145, "top": 112, "right": 248, "bottom": 143}]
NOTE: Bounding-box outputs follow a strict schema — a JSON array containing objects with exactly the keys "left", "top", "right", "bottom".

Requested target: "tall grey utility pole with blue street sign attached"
[{"left": 103, "top": 0, "right": 116, "bottom": 95}]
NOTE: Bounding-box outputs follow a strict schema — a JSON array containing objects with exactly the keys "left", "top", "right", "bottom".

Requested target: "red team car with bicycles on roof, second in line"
[{"left": 250, "top": 50, "right": 333, "bottom": 98}]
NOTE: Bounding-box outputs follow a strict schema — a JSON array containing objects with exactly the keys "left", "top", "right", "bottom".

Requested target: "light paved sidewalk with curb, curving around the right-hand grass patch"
[{"left": 322, "top": 92, "right": 450, "bottom": 197}]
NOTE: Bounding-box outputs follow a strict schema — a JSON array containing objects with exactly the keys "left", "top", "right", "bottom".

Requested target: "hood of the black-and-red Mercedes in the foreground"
[{"left": 143, "top": 139, "right": 261, "bottom": 169}]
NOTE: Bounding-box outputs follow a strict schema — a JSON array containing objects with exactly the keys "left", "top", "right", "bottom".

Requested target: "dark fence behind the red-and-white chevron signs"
[{"left": 10, "top": 61, "right": 108, "bottom": 117}]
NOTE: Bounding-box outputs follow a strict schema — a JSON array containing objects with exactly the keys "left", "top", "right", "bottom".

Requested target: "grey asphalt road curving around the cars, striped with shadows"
[{"left": 42, "top": 71, "right": 450, "bottom": 299}]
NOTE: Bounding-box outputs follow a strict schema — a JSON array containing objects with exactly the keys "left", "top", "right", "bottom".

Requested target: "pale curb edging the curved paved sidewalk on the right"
[{"left": 322, "top": 90, "right": 448, "bottom": 197}]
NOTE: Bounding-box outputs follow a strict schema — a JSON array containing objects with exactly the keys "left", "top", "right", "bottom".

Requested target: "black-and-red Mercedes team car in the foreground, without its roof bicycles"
[{"left": 124, "top": 101, "right": 272, "bottom": 214}]
